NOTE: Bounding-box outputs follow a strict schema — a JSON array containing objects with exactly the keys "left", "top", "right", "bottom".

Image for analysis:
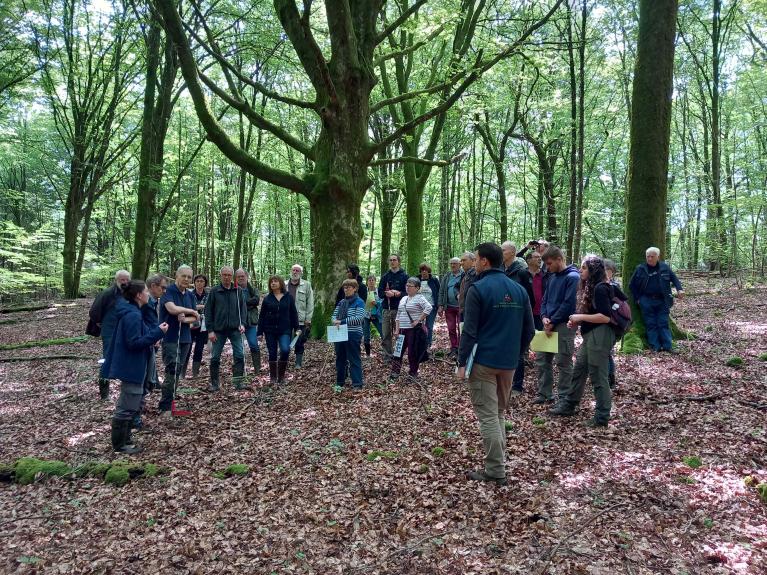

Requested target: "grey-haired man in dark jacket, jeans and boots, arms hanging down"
[{"left": 205, "top": 266, "right": 248, "bottom": 392}]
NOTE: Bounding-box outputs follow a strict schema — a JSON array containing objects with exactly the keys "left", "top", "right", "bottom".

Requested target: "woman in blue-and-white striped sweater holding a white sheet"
[{"left": 332, "top": 279, "right": 368, "bottom": 390}]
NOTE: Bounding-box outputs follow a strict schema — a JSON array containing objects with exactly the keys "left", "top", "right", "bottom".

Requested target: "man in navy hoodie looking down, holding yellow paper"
[{"left": 533, "top": 246, "right": 580, "bottom": 404}]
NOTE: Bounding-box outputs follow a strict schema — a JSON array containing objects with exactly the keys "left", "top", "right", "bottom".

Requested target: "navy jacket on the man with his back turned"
[{"left": 458, "top": 269, "right": 535, "bottom": 369}]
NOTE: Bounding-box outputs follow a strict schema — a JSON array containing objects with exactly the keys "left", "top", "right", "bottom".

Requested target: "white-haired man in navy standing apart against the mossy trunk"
[{"left": 629, "top": 247, "right": 684, "bottom": 352}]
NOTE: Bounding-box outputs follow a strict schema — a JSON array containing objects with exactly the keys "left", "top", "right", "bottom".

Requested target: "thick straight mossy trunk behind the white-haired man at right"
[{"left": 623, "top": 0, "right": 677, "bottom": 346}]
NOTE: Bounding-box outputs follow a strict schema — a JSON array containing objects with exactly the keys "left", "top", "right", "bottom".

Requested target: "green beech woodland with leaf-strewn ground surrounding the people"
[{"left": 0, "top": 0, "right": 767, "bottom": 575}]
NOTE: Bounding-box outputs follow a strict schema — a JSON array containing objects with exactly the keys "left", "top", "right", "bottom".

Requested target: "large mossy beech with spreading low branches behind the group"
[{"left": 155, "top": 0, "right": 563, "bottom": 333}]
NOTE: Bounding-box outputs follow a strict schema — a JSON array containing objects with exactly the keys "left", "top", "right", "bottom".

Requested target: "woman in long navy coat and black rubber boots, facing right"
[{"left": 104, "top": 280, "right": 168, "bottom": 454}]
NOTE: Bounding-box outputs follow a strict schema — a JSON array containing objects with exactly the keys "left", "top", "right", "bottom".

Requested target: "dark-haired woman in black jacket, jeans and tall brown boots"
[{"left": 258, "top": 276, "right": 300, "bottom": 383}]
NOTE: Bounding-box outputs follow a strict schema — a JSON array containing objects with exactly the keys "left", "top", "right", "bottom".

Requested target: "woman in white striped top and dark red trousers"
[{"left": 389, "top": 277, "right": 431, "bottom": 380}]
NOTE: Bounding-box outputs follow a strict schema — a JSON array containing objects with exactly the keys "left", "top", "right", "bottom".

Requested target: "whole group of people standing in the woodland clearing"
[{"left": 90, "top": 240, "right": 684, "bottom": 485}]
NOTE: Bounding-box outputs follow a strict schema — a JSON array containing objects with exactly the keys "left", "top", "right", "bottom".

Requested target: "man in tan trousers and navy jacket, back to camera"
[{"left": 457, "top": 242, "right": 534, "bottom": 485}]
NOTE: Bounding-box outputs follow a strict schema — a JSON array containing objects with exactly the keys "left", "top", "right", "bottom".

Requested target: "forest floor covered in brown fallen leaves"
[{"left": 0, "top": 280, "right": 767, "bottom": 575}]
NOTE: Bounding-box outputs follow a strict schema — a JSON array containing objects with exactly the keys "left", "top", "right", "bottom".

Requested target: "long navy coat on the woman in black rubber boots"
[{"left": 104, "top": 297, "right": 163, "bottom": 385}]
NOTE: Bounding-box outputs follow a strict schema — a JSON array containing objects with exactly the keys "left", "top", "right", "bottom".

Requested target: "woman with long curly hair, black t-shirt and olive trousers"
[{"left": 549, "top": 255, "right": 615, "bottom": 427}]
